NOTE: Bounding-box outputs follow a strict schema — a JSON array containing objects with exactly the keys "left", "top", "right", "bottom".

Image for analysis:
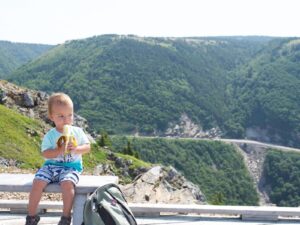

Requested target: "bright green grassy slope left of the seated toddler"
[{"left": 0, "top": 105, "right": 43, "bottom": 168}]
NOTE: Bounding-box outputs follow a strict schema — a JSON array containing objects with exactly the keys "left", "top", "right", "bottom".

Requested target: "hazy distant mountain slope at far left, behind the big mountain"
[{"left": 0, "top": 41, "right": 53, "bottom": 79}]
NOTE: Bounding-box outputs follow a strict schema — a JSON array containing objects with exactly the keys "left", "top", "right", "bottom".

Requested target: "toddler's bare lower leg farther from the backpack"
[{"left": 28, "top": 180, "right": 48, "bottom": 216}]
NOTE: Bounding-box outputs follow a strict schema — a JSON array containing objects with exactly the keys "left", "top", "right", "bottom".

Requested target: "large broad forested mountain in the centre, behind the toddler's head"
[{"left": 9, "top": 35, "right": 270, "bottom": 134}]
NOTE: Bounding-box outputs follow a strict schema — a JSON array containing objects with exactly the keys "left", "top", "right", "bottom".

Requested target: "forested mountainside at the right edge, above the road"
[{"left": 227, "top": 38, "right": 300, "bottom": 146}]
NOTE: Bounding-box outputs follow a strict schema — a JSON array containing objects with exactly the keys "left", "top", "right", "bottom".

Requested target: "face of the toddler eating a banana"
[{"left": 49, "top": 104, "right": 73, "bottom": 133}]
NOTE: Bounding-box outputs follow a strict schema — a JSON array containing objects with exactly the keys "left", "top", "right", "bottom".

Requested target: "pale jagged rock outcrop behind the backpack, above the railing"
[{"left": 121, "top": 166, "right": 205, "bottom": 204}]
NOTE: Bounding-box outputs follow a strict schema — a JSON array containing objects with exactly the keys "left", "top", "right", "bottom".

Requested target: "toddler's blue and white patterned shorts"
[{"left": 34, "top": 165, "right": 80, "bottom": 185}]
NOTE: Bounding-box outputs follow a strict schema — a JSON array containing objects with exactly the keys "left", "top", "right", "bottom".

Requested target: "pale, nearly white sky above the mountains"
[{"left": 0, "top": 0, "right": 300, "bottom": 44}]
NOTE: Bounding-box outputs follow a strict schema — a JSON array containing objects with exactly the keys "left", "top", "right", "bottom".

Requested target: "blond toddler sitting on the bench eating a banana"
[{"left": 25, "top": 93, "right": 90, "bottom": 225}]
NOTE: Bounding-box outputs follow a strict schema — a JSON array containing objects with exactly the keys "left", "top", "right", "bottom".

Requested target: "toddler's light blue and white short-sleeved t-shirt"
[{"left": 41, "top": 126, "right": 90, "bottom": 172}]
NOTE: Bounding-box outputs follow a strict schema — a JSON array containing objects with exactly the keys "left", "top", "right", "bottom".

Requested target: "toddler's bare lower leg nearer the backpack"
[{"left": 60, "top": 181, "right": 75, "bottom": 217}]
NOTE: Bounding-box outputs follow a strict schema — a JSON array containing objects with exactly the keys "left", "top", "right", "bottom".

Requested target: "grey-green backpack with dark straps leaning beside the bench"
[{"left": 82, "top": 183, "right": 137, "bottom": 225}]
